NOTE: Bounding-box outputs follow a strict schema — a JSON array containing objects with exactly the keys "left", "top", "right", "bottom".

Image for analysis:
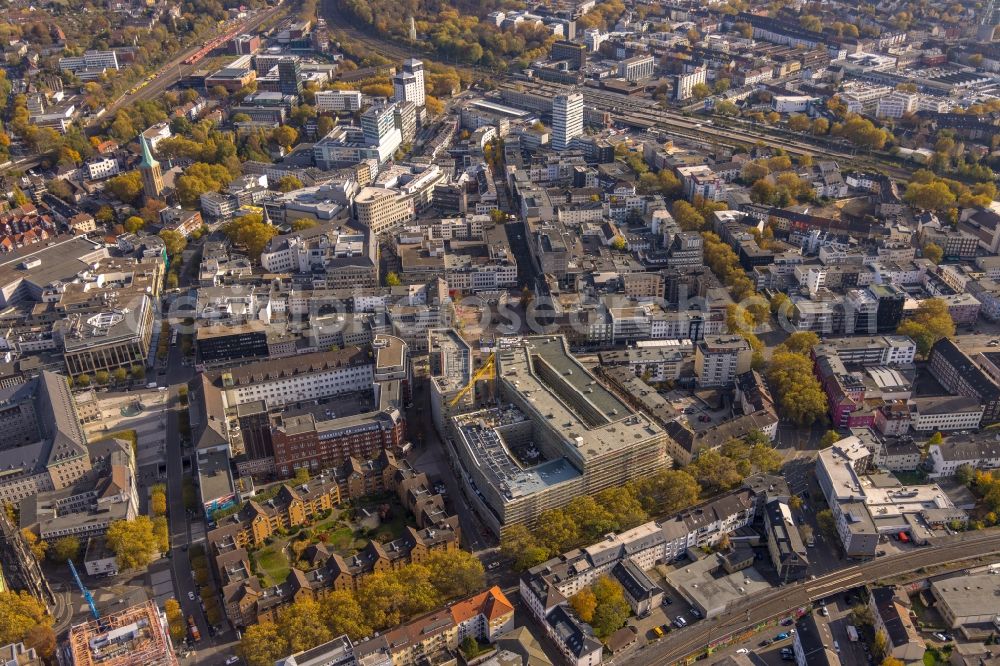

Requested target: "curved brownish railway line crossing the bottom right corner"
[{"left": 634, "top": 528, "right": 1000, "bottom": 665}]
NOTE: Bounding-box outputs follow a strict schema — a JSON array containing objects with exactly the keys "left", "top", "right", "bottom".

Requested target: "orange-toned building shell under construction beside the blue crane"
[{"left": 69, "top": 601, "right": 177, "bottom": 666}]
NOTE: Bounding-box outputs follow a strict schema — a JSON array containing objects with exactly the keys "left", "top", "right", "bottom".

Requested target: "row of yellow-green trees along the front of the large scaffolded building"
[{"left": 500, "top": 432, "right": 781, "bottom": 570}]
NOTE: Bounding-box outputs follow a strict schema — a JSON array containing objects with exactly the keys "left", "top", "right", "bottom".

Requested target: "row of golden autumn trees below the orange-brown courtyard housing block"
[{"left": 239, "top": 550, "right": 485, "bottom": 666}]
